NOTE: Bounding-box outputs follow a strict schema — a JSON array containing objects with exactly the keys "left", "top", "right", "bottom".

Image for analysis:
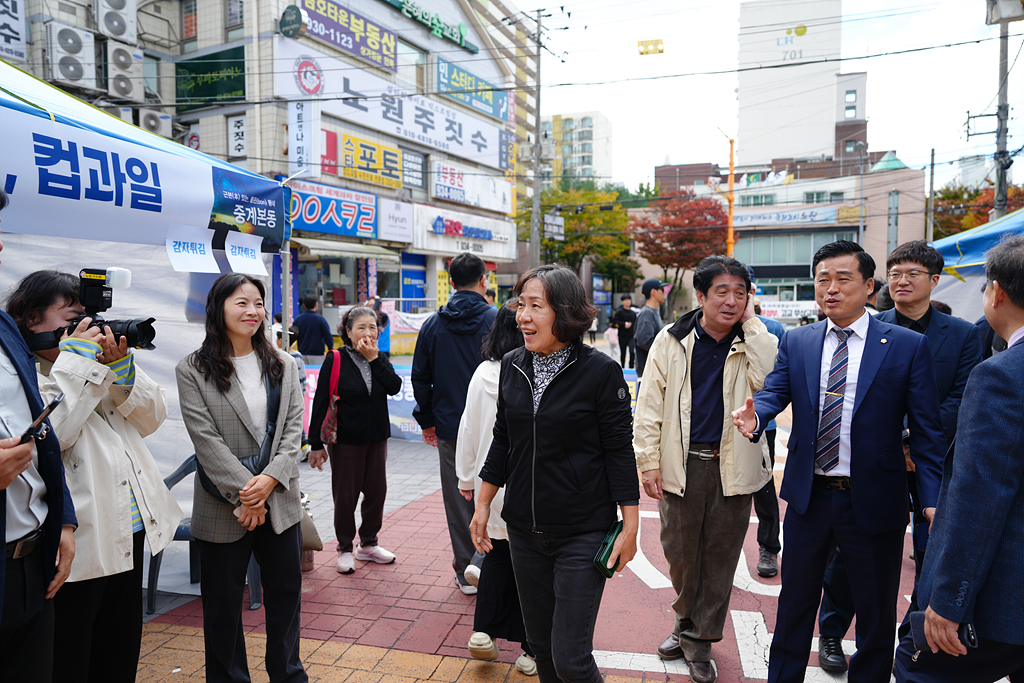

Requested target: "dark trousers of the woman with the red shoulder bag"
[{"left": 328, "top": 441, "right": 387, "bottom": 553}]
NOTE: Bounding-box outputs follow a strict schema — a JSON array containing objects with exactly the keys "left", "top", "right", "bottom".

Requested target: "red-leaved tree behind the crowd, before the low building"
[{"left": 630, "top": 190, "right": 729, "bottom": 311}]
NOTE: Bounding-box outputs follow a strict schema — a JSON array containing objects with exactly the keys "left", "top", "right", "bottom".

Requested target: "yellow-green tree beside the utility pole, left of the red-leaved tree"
[{"left": 516, "top": 187, "right": 629, "bottom": 274}]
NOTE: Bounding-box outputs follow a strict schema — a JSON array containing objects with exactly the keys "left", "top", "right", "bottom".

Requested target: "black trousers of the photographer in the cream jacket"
[{"left": 53, "top": 531, "right": 145, "bottom": 683}]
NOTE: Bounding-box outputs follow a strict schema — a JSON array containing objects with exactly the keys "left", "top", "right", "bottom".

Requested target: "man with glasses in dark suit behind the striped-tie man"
[{"left": 818, "top": 240, "right": 981, "bottom": 671}]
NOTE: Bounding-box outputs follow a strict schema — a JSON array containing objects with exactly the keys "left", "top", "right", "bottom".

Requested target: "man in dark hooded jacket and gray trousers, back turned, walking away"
[{"left": 412, "top": 253, "right": 498, "bottom": 595}]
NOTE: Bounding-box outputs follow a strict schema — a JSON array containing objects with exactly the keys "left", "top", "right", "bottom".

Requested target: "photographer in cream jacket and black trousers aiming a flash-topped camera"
[{"left": 7, "top": 270, "right": 181, "bottom": 682}]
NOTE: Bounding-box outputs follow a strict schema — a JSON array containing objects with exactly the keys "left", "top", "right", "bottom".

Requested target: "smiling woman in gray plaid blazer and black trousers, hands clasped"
[{"left": 177, "top": 273, "right": 308, "bottom": 683}]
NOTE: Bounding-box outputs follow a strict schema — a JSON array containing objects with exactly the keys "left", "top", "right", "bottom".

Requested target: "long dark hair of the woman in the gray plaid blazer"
[{"left": 188, "top": 272, "right": 285, "bottom": 393}]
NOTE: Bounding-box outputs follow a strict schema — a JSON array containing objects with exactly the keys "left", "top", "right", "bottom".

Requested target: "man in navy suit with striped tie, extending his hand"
[{"left": 732, "top": 241, "right": 944, "bottom": 683}]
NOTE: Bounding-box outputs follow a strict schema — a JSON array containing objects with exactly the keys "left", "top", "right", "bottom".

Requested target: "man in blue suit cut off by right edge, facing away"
[{"left": 895, "top": 236, "right": 1024, "bottom": 683}]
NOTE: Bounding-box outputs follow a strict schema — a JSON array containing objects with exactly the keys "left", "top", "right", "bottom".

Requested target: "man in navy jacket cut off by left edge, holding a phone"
[{"left": 0, "top": 189, "right": 78, "bottom": 683}]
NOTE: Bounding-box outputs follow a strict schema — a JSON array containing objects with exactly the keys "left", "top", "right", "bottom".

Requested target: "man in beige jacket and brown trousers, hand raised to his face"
[{"left": 633, "top": 256, "right": 778, "bottom": 683}]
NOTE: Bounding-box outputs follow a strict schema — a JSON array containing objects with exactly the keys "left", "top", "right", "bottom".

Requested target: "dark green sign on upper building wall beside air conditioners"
[{"left": 174, "top": 45, "right": 246, "bottom": 114}]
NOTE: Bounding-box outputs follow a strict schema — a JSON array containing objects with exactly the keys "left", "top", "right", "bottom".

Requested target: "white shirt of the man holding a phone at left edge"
[{"left": 0, "top": 346, "right": 47, "bottom": 543}]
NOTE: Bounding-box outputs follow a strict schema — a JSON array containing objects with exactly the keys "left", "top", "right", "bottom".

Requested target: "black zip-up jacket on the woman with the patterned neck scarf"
[{"left": 480, "top": 341, "right": 640, "bottom": 533}]
